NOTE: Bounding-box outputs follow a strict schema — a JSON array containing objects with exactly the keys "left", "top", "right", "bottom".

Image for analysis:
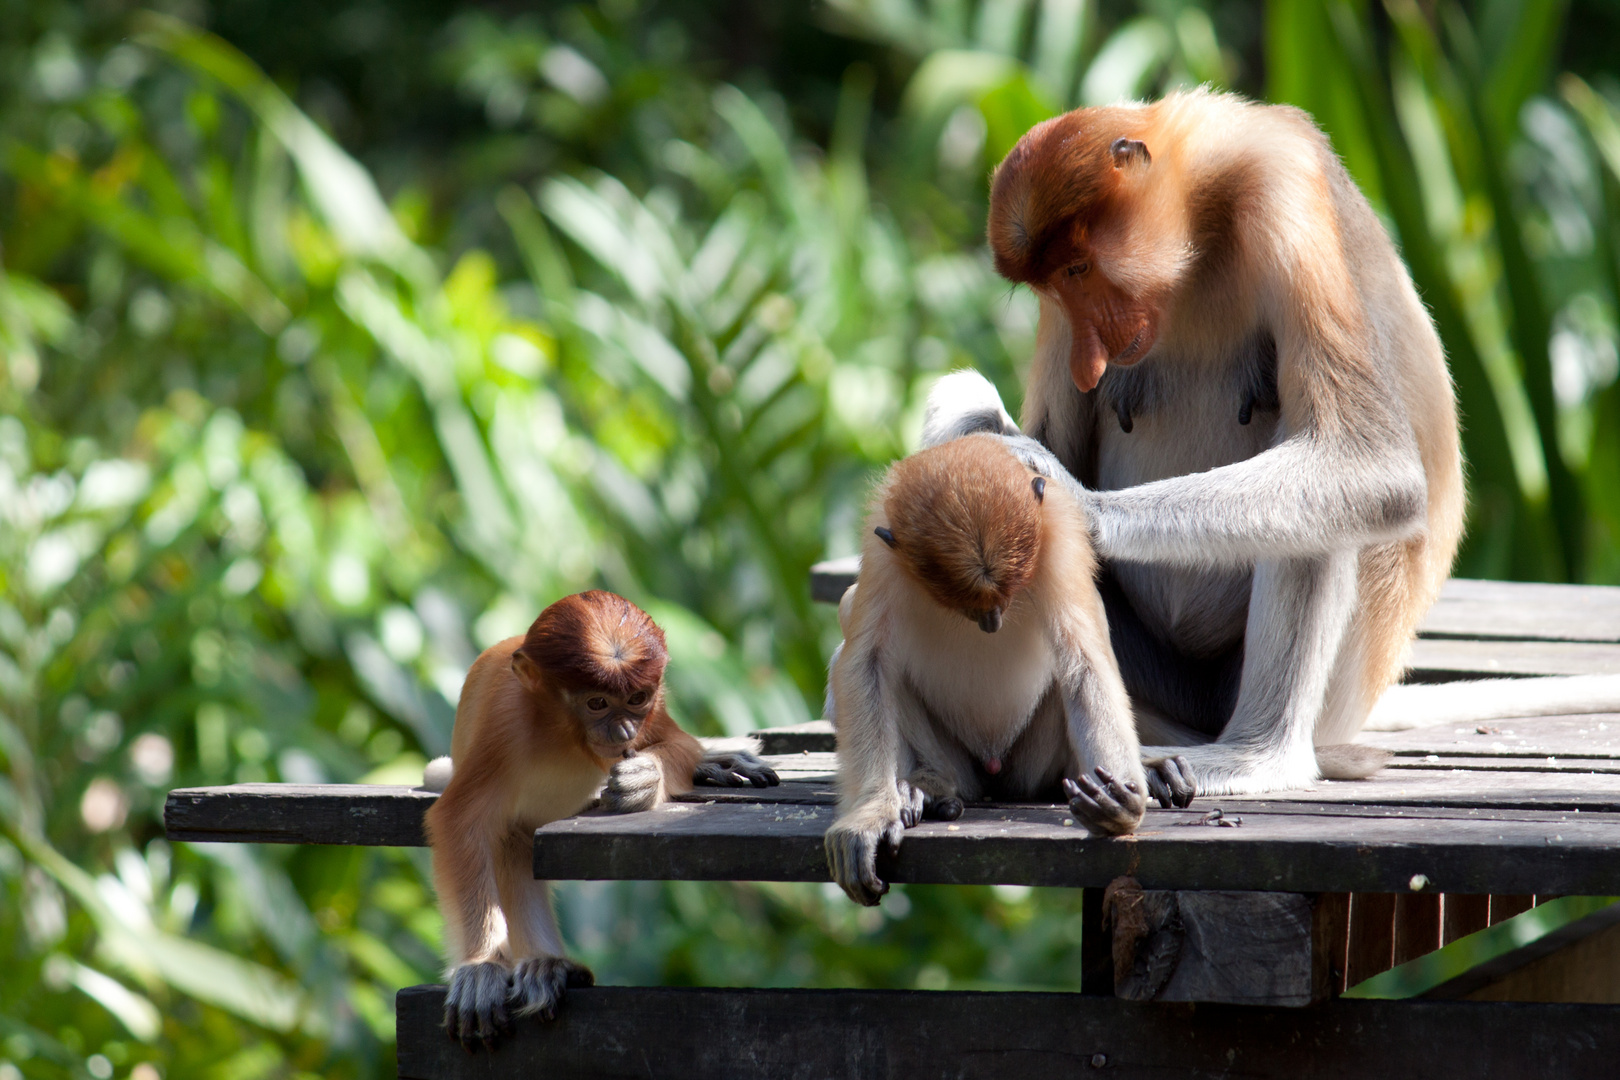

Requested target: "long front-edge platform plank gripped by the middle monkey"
[{"left": 535, "top": 803, "right": 1620, "bottom": 895}]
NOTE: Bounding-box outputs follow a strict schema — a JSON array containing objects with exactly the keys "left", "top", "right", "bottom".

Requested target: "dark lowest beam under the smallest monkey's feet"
[{"left": 397, "top": 986, "right": 1620, "bottom": 1080}]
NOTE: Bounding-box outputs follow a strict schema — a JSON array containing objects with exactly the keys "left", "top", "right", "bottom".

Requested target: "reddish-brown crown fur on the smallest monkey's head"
[{"left": 514, "top": 589, "right": 669, "bottom": 696}]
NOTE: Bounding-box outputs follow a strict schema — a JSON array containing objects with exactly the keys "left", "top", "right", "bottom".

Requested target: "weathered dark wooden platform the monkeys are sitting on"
[{"left": 165, "top": 582, "right": 1620, "bottom": 1080}]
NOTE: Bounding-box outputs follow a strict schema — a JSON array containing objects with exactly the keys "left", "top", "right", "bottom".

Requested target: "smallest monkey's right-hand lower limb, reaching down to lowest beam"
[{"left": 496, "top": 829, "right": 596, "bottom": 1020}]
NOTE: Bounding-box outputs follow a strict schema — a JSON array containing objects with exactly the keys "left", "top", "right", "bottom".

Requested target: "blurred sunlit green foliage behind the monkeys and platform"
[{"left": 0, "top": 0, "right": 1620, "bottom": 1080}]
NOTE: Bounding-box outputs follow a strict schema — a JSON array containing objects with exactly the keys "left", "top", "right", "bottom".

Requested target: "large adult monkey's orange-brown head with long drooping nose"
[{"left": 987, "top": 105, "right": 1186, "bottom": 390}]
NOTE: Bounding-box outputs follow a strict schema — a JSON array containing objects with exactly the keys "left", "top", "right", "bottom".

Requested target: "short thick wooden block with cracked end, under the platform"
[{"left": 1108, "top": 878, "right": 1332, "bottom": 1009}]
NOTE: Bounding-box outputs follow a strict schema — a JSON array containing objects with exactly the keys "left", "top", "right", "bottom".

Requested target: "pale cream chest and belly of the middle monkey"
[{"left": 894, "top": 589, "right": 1053, "bottom": 759}]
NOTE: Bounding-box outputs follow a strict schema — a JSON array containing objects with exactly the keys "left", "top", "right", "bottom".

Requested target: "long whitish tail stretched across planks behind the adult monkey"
[{"left": 1362, "top": 675, "right": 1620, "bottom": 732}]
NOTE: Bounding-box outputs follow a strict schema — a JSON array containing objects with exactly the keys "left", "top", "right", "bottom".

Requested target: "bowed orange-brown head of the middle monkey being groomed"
[{"left": 878, "top": 434, "right": 1045, "bottom": 631}]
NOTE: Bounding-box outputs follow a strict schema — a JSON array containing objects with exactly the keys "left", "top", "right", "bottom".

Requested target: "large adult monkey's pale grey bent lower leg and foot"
[{"left": 1142, "top": 551, "right": 1356, "bottom": 795}]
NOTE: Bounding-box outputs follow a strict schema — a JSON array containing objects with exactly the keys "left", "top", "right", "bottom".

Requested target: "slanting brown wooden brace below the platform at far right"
[{"left": 1424, "top": 904, "right": 1620, "bottom": 1004}]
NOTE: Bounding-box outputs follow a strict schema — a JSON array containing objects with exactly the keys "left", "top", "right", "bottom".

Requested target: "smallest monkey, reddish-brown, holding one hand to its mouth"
[{"left": 424, "top": 591, "right": 778, "bottom": 1049}]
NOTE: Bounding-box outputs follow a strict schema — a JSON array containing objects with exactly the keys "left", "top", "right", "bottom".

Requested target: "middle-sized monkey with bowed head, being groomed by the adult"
[{"left": 825, "top": 372, "right": 1194, "bottom": 905}]
